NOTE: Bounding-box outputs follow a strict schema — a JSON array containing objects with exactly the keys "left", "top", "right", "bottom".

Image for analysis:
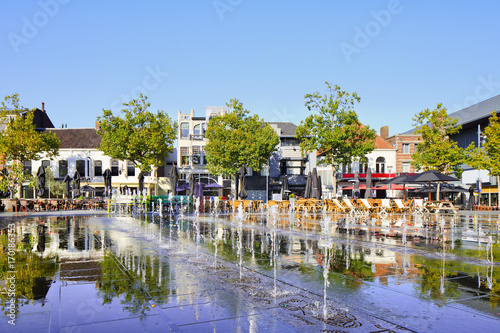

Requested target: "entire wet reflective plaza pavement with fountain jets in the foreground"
[{"left": 0, "top": 212, "right": 500, "bottom": 332}]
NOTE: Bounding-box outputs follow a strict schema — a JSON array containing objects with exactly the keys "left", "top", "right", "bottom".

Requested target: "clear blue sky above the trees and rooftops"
[{"left": 0, "top": 0, "right": 500, "bottom": 135}]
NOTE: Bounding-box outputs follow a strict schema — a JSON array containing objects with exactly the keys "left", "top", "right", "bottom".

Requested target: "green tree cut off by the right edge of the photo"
[{"left": 467, "top": 111, "right": 500, "bottom": 209}]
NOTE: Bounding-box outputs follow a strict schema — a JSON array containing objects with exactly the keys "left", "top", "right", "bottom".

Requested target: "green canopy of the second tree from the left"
[{"left": 97, "top": 94, "right": 177, "bottom": 172}]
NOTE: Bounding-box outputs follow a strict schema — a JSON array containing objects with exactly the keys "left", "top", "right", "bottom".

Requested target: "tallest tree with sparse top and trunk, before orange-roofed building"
[{"left": 295, "top": 82, "right": 377, "bottom": 193}]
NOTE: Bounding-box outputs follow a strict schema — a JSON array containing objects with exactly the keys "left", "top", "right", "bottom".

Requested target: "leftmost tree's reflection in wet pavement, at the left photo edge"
[{"left": 0, "top": 229, "right": 57, "bottom": 314}]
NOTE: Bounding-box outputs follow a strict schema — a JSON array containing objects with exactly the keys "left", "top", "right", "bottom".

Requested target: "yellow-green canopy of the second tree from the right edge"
[{"left": 411, "top": 103, "right": 474, "bottom": 178}]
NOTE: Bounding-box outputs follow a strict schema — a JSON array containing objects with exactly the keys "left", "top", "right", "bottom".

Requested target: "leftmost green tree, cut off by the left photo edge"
[{"left": 0, "top": 94, "right": 61, "bottom": 195}]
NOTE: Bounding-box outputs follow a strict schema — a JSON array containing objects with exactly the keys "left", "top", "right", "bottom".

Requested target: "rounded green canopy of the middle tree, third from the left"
[{"left": 204, "top": 99, "right": 279, "bottom": 175}]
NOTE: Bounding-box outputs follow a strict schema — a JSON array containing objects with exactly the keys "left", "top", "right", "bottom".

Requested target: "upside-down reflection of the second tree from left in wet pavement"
[{"left": 98, "top": 251, "right": 170, "bottom": 318}]
